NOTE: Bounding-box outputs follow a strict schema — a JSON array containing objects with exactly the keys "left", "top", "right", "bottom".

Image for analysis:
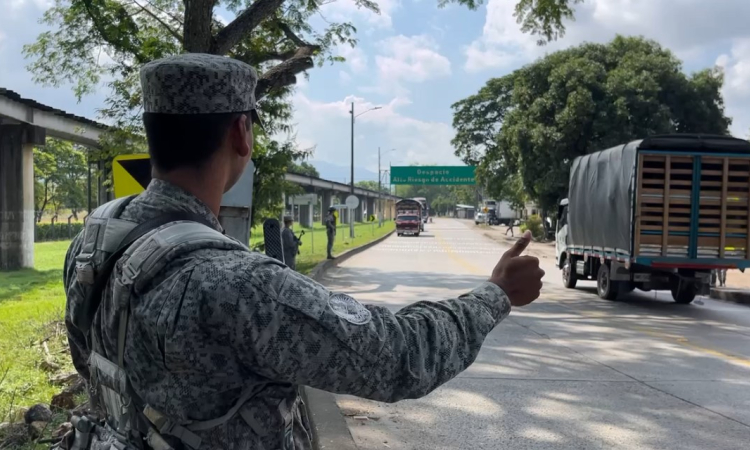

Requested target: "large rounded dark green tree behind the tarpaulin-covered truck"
[{"left": 453, "top": 36, "right": 731, "bottom": 210}]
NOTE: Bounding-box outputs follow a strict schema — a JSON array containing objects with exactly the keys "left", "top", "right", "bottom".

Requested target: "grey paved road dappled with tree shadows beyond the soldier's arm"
[{"left": 323, "top": 219, "right": 750, "bottom": 450}]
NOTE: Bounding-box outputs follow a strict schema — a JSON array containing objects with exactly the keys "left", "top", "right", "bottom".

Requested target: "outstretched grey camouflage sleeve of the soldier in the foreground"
[{"left": 222, "top": 255, "right": 510, "bottom": 402}]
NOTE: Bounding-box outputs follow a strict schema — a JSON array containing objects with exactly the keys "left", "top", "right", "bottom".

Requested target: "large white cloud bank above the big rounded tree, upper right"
[{"left": 464, "top": 0, "right": 750, "bottom": 137}]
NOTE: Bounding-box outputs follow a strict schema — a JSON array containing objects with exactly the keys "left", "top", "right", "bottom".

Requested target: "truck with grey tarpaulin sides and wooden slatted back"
[{"left": 556, "top": 134, "right": 750, "bottom": 303}]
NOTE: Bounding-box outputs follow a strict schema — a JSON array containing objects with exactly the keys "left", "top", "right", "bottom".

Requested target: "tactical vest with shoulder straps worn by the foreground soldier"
[{"left": 61, "top": 197, "right": 293, "bottom": 450}]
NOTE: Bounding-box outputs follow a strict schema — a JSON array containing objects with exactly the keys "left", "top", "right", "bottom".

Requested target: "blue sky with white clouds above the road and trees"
[{"left": 0, "top": 0, "right": 750, "bottom": 181}]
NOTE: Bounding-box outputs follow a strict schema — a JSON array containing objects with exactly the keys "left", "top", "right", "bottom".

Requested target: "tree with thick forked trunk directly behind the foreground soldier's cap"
[{"left": 24, "top": 0, "right": 577, "bottom": 223}]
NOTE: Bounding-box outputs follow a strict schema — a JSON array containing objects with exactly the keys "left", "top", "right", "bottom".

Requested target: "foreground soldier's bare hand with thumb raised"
[{"left": 489, "top": 231, "right": 544, "bottom": 306}]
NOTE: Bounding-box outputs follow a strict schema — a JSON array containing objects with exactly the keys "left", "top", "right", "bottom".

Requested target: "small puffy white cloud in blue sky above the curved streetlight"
[{"left": 375, "top": 35, "right": 451, "bottom": 84}]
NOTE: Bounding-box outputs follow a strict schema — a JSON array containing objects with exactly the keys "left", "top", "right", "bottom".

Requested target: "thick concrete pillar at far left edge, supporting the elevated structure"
[{"left": 0, "top": 124, "right": 45, "bottom": 270}]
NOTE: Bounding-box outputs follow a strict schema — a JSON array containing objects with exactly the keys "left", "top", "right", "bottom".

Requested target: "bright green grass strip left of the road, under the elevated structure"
[{"left": 0, "top": 221, "right": 395, "bottom": 422}]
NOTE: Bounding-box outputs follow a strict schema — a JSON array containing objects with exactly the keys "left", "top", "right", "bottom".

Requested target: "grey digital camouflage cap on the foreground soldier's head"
[{"left": 141, "top": 53, "right": 260, "bottom": 128}]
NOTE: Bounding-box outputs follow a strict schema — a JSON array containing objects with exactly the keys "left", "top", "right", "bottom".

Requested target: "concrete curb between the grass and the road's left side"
[{"left": 302, "top": 230, "right": 396, "bottom": 450}]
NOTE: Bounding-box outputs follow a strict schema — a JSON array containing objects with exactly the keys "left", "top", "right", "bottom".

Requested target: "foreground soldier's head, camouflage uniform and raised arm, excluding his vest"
[{"left": 64, "top": 54, "right": 544, "bottom": 450}]
